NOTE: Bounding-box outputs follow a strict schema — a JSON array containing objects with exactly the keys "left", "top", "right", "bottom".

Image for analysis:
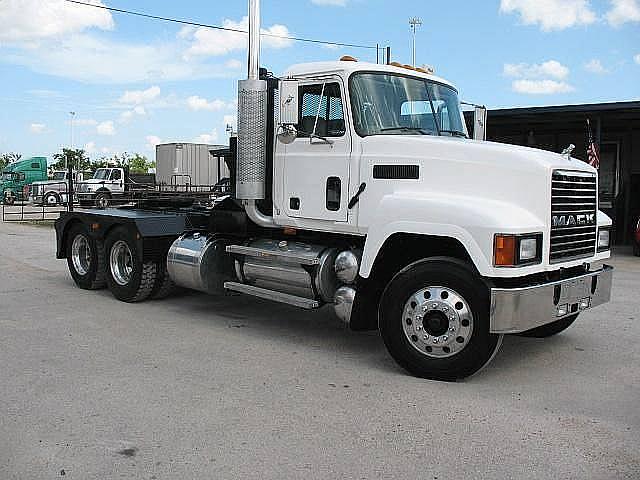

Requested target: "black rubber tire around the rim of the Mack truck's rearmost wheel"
[{"left": 66, "top": 224, "right": 107, "bottom": 290}]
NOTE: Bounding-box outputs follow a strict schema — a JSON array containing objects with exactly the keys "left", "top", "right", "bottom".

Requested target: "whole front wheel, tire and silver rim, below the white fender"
[{"left": 380, "top": 258, "right": 502, "bottom": 381}]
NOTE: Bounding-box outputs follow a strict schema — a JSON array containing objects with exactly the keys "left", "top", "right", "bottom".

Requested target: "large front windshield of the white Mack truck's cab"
[{"left": 351, "top": 73, "right": 467, "bottom": 137}]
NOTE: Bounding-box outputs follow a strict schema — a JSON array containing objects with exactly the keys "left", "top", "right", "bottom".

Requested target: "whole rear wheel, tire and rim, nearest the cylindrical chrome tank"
[{"left": 105, "top": 227, "right": 157, "bottom": 302}]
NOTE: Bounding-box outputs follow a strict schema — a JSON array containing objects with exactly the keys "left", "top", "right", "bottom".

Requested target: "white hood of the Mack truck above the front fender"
[{"left": 361, "top": 135, "right": 596, "bottom": 233}]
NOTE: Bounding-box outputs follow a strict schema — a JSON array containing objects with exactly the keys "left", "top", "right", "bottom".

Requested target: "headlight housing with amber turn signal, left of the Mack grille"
[{"left": 493, "top": 233, "right": 542, "bottom": 267}]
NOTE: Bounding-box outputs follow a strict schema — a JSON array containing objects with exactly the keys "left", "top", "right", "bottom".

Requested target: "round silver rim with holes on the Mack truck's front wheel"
[{"left": 402, "top": 286, "right": 473, "bottom": 358}]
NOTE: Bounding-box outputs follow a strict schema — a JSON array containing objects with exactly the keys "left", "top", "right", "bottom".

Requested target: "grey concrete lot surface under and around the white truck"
[{"left": 0, "top": 219, "right": 640, "bottom": 480}]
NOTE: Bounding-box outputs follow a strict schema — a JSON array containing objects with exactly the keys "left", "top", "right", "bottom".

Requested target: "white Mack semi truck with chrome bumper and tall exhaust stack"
[{"left": 56, "top": 0, "right": 612, "bottom": 380}]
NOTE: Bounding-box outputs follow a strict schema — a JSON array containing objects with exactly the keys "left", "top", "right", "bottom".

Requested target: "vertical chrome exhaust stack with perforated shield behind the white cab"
[{"left": 236, "top": 0, "right": 267, "bottom": 201}]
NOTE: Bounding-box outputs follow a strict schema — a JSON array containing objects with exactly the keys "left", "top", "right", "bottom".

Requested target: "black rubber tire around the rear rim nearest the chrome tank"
[{"left": 105, "top": 227, "right": 158, "bottom": 303}]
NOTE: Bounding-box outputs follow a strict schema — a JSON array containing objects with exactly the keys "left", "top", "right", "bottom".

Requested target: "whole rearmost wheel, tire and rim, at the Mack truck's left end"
[{"left": 66, "top": 224, "right": 106, "bottom": 290}]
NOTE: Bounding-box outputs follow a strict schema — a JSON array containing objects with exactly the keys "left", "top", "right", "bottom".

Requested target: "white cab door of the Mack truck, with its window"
[{"left": 283, "top": 78, "right": 351, "bottom": 222}]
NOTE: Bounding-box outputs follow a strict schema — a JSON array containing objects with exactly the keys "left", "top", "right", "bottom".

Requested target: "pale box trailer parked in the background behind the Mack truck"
[{"left": 156, "top": 143, "right": 229, "bottom": 186}]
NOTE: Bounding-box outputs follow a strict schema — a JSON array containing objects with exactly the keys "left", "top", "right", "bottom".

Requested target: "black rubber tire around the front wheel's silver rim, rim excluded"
[{"left": 380, "top": 257, "right": 502, "bottom": 381}]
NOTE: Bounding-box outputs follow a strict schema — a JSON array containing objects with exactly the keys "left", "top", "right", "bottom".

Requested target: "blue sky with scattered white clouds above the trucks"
[{"left": 0, "top": 0, "right": 640, "bottom": 163}]
